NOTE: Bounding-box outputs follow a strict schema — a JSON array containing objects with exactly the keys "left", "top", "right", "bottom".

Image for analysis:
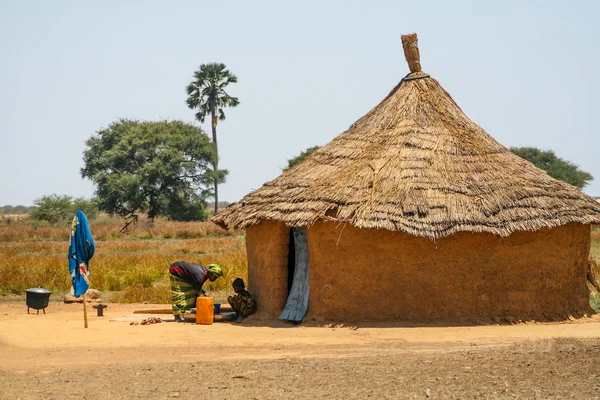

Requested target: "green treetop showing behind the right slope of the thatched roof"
[{"left": 510, "top": 147, "right": 594, "bottom": 189}]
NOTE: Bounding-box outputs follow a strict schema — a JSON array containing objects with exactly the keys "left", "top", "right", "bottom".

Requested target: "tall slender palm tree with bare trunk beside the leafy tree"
[{"left": 186, "top": 63, "right": 240, "bottom": 214}]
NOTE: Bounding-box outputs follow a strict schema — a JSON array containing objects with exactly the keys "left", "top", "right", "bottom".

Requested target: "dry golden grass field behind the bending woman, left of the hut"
[{"left": 0, "top": 217, "right": 248, "bottom": 303}]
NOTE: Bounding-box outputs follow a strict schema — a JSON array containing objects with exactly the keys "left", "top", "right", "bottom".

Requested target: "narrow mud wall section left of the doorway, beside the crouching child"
[{"left": 246, "top": 221, "right": 290, "bottom": 317}]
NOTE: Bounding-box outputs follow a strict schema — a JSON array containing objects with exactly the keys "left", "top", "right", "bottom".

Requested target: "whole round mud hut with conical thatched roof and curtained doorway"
[{"left": 213, "top": 34, "right": 600, "bottom": 321}]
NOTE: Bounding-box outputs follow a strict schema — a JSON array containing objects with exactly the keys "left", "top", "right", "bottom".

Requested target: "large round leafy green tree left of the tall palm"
[{"left": 81, "top": 119, "right": 220, "bottom": 220}]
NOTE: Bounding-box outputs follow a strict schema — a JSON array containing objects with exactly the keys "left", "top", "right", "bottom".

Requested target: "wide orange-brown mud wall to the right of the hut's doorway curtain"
[{"left": 308, "top": 222, "right": 590, "bottom": 321}]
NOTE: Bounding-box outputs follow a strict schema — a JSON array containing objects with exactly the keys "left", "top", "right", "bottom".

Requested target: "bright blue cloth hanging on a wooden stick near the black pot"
[{"left": 69, "top": 210, "right": 96, "bottom": 297}]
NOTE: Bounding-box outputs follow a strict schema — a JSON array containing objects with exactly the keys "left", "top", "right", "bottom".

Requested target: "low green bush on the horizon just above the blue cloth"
[{"left": 30, "top": 194, "right": 98, "bottom": 224}]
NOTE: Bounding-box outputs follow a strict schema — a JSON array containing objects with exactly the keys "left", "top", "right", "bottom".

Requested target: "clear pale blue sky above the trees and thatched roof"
[{"left": 0, "top": 0, "right": 600, "bottom": 205}]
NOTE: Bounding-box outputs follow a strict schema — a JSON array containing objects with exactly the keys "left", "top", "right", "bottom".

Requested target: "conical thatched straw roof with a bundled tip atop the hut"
[{"left": 213, "top": 34, "right": 600, "bottom": 240}]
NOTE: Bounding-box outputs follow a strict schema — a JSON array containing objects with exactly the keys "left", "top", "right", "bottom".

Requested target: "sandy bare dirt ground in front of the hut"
[{"left": 0, "top": 303, "right": 600, "bottom": 400}]
